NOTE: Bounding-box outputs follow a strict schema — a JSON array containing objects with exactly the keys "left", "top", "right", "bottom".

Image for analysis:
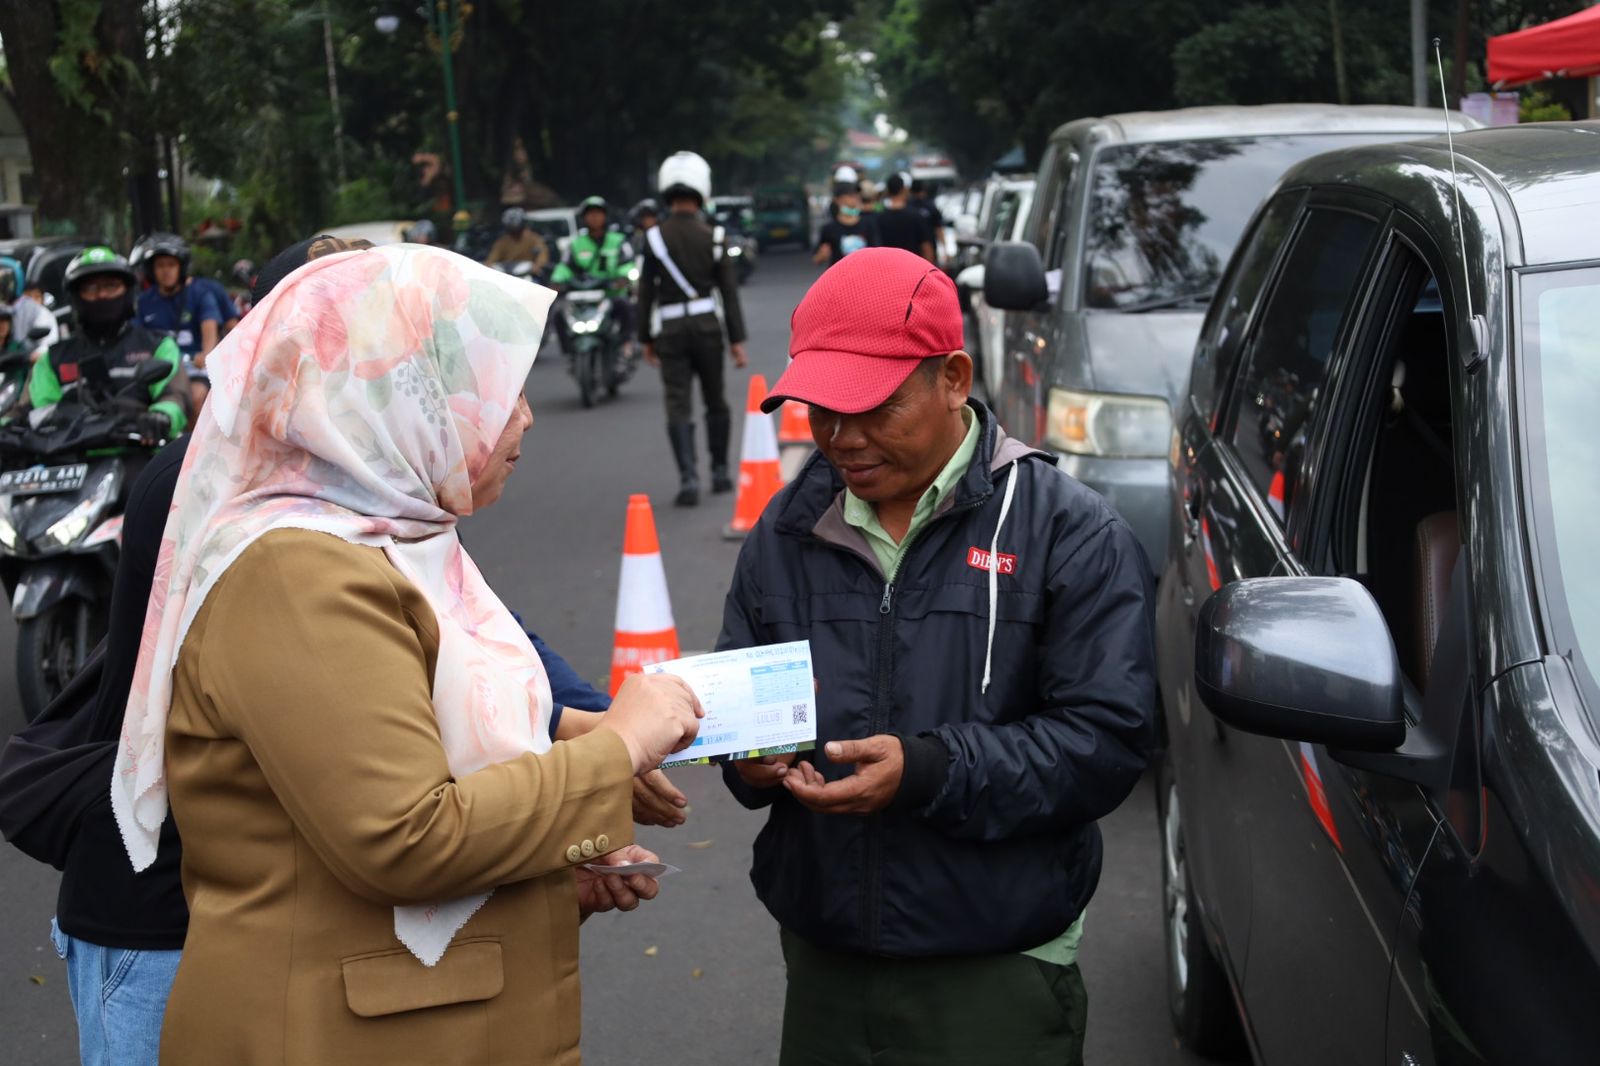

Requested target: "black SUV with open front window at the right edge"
[{"left": 1158, "top": 123, "right": 1600, "bottom": 1066}]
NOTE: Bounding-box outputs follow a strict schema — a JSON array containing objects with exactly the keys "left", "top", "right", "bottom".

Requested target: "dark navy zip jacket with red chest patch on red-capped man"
[{"left": 717, "top": 403, "right": 1155, "bottom": 957}]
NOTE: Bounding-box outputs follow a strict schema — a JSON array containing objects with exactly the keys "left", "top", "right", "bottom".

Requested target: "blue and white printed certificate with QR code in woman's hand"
[{"left": 645, "top": 640, "right": 816, "bottom": 767}]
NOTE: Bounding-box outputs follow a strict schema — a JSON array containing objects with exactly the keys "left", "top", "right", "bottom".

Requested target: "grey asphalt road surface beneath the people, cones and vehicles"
[{"left": 0, "top": 253, "right": 1200, "bottom": 1066}]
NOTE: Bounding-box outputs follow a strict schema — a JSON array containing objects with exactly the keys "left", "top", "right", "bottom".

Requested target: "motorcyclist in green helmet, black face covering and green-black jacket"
[{"left": 21, "top": 246, "right": 190, "bottom": 445}]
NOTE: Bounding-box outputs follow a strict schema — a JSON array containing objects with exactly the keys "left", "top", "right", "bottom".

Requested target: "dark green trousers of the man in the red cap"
[{"left": 779, "top": 930, "right": 1090, "bottom": 1066}]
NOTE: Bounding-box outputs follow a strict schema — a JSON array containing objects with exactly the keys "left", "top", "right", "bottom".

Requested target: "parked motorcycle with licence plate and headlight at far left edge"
[{"left": 0, "top": 360, "right": 168, "bottom": 720}]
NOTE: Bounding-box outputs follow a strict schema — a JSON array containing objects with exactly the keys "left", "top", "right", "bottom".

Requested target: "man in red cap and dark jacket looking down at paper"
[{"left": 717, "top": 248, "right": 1155, "bottom": 1066}]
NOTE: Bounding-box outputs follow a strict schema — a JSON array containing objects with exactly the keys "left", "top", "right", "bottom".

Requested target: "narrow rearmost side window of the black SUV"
[{"left": 1189, "top": 192, "right": 1306, "bottom": 431}]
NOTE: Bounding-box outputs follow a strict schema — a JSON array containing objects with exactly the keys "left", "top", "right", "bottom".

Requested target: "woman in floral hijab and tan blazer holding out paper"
[{"left": 112, "top": 246, "right": 699, "bottom": 1064}]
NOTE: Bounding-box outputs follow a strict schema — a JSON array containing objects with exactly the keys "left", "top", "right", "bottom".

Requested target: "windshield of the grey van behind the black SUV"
[{"left": 1083, "top": 133, "right": 1416, "bottom": 311}]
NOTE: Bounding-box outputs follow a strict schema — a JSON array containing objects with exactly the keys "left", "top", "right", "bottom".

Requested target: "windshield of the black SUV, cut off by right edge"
[{"left": 1522, "top": 267, "right": 1600, "bottom": 713}]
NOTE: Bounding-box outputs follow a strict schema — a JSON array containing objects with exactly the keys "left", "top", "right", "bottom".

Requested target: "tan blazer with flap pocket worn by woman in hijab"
[{"left": 162, "top": 530, "right": 634, "bottom": 1066}]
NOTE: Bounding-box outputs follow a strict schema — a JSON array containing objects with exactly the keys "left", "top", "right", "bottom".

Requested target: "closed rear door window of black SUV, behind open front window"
[{"left": 1229, "top": 208, "right": 1378, "bottom": 522}]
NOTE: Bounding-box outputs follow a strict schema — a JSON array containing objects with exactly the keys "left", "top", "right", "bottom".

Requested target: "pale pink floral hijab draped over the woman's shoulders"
[{"left": 110, "top": 245, "right": 555, "bottom": 965}]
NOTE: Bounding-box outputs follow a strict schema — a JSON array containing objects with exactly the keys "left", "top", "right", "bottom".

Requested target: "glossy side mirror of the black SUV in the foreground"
[{"left": 1195, "top": 578, "right": 1406, "bottom": 752}]
